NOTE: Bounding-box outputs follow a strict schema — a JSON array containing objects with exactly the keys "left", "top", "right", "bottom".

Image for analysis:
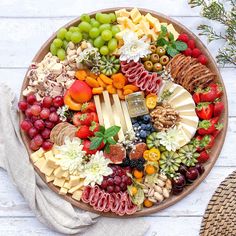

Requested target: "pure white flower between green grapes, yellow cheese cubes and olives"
[{"left": 120, "top": 30, "right": 151, "bottom": 62}]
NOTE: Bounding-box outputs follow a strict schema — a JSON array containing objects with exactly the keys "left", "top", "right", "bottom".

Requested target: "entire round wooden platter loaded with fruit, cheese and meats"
[{"left": 19, "top": 8, "right": 228, "bottom": 217}]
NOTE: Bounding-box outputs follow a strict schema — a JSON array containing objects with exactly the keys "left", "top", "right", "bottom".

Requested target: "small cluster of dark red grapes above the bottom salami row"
[{"left": 101, "top": 165, "right": 132, "bottom": 193}]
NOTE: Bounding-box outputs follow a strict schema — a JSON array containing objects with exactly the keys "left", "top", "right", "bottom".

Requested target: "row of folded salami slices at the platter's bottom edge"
[{"left": 81, "top": 186, "right": 137, "bottom": 216}]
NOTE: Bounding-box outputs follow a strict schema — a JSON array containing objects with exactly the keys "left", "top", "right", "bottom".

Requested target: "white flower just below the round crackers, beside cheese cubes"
[{"left": 55, "top": 137, "right": 86, "bottom": 175}]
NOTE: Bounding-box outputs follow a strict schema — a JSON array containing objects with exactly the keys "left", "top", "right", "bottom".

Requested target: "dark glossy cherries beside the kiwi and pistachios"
[{"left": 172, "top": 163, "right": 205, "bottom": 195}]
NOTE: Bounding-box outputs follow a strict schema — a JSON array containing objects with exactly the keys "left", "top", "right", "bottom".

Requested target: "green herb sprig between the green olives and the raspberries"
[{"left": 156, "top": 25, "right": 187, "bottom": 57}]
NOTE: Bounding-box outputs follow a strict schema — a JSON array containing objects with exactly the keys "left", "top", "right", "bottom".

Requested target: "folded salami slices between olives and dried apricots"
[{"left": 121, "top": 61, "right": 162, "bottom": 93}]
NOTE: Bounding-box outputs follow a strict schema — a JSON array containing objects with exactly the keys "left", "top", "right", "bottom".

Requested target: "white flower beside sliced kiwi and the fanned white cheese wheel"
[{"left": 157, "top": 127, "right": 183, "bottom": 151}]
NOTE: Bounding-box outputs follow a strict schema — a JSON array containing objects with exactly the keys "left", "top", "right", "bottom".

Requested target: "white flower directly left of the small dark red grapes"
[{"left": 82, "top": 151, "right": 112, "bottom": 186}]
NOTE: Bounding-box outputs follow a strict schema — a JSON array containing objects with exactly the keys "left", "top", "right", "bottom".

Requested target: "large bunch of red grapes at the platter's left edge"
[{"left": 18, "top": 94, "right": 64, "bottom": 151}]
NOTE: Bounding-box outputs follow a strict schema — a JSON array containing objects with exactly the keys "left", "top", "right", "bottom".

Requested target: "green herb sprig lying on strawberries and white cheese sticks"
[{"left": 89, "top": 125, "right": 120, "bottom": 153}]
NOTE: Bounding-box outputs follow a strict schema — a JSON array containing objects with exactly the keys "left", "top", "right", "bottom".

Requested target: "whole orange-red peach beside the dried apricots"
[{"left": 69, "top": 80, "right": 92, "bottom": 103}]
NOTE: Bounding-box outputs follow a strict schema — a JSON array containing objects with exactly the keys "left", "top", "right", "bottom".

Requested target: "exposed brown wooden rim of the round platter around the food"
[{"left": 20, "top": 8, "right": 228, "bottom": 217}]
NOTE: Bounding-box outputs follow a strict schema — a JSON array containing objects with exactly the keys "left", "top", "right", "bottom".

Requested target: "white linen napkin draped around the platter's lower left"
[{"left": 0, "top": 84, "right": 149, "bottom": 236}]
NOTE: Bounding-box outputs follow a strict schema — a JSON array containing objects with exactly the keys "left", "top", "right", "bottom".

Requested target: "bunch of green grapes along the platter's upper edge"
[{"left": 50, "top": 13, "right": 120, "bottom": 60}]
